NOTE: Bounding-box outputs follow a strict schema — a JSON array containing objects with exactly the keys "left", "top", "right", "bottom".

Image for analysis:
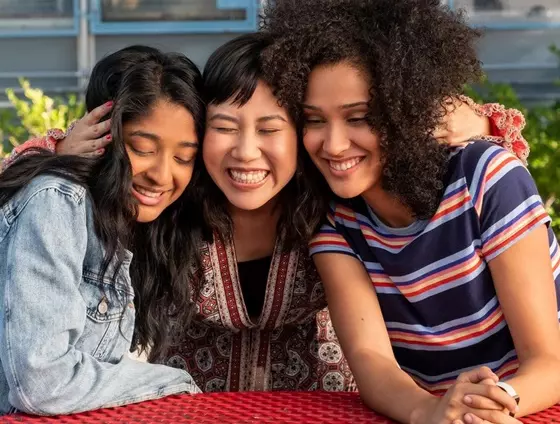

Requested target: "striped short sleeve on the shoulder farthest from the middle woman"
[{"left": 469, "top": 147, "right": 550, "bottom": 261}]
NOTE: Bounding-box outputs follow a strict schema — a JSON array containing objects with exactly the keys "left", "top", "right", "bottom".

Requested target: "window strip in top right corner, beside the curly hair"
[{"left": 450, "top": 0, "right": 560, "bottom": 29}]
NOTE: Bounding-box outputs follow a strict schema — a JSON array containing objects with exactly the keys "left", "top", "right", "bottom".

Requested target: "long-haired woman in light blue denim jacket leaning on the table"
[{"left": 0, "top": 46, "right": 205, "bottom": 415}]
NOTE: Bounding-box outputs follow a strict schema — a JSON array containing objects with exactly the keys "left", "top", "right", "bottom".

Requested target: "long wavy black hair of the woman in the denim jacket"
[{"left": 0, "top": 46, "right": 206, "bottom": 360}]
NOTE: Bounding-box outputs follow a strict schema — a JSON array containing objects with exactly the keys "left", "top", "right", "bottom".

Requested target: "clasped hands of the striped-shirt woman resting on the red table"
[{"left": 413, "top": 367, "right": 520, "bottom": 424}]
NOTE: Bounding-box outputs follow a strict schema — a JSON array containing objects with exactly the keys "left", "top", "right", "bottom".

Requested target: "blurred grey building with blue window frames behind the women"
[{"left": 0, "top": 0, "right": 560, "bottom": 107}]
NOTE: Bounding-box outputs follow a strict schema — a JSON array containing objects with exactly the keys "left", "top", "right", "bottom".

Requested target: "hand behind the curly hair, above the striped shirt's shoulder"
[{"left": 433, "top": 98, "right": 490, "bottom": 146}]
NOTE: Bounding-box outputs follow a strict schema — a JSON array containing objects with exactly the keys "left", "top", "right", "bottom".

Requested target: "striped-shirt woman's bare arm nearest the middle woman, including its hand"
[{"left": 314, "top": 253, "right": 519, "bottom": 424}]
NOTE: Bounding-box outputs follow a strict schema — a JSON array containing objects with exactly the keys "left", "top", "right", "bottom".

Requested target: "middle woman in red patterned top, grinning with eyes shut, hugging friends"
[{"left": 7, "top": 33, "right": 532, "bottom": 398}]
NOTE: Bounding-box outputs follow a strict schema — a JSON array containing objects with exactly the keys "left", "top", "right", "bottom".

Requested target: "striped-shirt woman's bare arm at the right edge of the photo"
[{"left": 489, "top": 224, "right": 560, "bottom": 416}]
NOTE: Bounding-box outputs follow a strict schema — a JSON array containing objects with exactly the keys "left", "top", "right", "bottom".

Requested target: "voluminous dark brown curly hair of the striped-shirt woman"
[{"left": 261, "top": 0, "right": 482, "bottom": 219}]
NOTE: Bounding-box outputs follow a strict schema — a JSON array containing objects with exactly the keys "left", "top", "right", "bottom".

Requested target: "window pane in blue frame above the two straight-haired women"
[{"left": 102, "top": 0, "right": 247, "bottom": 22}]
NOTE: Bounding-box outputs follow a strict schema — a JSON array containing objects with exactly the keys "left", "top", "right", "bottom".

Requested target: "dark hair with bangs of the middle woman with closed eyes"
[{"left": 199, "top": 33, "right": 325, "bottom": 249}]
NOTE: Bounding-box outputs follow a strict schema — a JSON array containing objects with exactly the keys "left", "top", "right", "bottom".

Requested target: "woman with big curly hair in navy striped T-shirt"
[{"left": 263, "top": 0, "right": 560, "bottom": 424}]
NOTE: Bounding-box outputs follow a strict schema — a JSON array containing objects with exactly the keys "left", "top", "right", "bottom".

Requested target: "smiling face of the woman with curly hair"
[{"left": 303, "top": 63, "right": 382, "bottom": 198}]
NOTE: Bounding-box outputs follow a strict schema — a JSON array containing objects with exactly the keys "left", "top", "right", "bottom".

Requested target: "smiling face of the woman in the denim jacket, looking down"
[{"left": 123, "top": 100, "right": 198, "bottom": 222}]
